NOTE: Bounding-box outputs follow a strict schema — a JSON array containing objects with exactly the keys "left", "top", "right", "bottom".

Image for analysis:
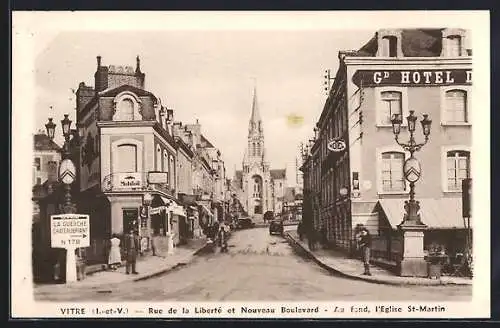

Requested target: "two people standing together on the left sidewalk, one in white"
[{"left": 108, "top": 229, "right": 141, "bottom": 274}]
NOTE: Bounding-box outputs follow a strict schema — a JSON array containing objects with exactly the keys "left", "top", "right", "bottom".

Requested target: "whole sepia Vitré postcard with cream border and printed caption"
[{"left": 10, "top": 11, "right": 490, "bottom": 319}]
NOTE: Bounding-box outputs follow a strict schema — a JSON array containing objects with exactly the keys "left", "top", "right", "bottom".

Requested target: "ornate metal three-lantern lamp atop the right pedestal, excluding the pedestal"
[{"left": 391, "top": 111, "right": 432, "bottom": 225}]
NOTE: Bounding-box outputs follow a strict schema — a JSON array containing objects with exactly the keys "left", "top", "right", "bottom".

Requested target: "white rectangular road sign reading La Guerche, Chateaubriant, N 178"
[{"left": 50, "top": 214, "right": 90, "bottom": 248}]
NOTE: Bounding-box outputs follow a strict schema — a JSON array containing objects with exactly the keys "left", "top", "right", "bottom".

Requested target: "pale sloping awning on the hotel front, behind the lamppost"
[{"left": 379, "top": 198, "right": 472, "bottom": 229}]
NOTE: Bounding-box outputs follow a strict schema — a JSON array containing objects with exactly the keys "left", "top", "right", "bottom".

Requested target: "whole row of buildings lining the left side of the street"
[{"left": 33, "top": 56, "right": 243, "bottom": 280}]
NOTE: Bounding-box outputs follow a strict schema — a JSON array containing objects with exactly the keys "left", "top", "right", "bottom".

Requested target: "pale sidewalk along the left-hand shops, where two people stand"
[{"left": 35, "top": 238, "right": 206, "bottom": 293}]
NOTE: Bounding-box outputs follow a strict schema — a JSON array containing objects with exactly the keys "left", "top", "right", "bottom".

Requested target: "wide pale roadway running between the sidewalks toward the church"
[{"left": 37, "top": 227, "right": 471, "bottom": 302}]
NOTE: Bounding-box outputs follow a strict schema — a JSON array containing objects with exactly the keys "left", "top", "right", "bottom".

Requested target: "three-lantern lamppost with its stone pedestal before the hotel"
[{"left": 391, "top": 111, "right": 432, "bottom": 277}]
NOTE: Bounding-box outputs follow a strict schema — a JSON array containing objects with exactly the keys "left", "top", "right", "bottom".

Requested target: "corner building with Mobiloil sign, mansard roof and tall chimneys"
[{"left": 76, "top": 56, "right": 186, "bottom": 262}]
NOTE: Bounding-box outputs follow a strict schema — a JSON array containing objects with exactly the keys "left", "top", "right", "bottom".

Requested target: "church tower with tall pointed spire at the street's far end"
[{"left": 242, "top": 88, "right": 273, "bottom": 221}]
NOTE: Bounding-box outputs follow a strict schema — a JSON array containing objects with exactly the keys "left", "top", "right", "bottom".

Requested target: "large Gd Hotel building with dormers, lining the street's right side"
[{"left": 301, "top": 28, "right": 472, "bottom": 272}]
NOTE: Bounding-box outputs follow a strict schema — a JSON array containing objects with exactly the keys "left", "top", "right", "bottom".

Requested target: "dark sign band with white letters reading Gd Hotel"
[{"left": 352, "top": 69, "right": 472, "bottom": 87}]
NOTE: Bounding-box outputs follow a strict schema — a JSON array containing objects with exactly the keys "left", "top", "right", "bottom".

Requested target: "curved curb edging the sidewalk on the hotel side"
[{"left": 285, "top": 233, "right": 472, "bottom": 286}]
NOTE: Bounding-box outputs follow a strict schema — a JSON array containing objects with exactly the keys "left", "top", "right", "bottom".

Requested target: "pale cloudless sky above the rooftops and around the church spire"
[{"left": 31, "top": 25, "right": 374, "bottom": 184}]
